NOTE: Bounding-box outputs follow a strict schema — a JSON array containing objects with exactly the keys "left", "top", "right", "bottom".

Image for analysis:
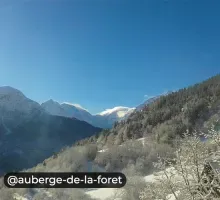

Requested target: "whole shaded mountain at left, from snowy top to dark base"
[{"left": 0, "top": 86, "right": 101, "bottom": 172}]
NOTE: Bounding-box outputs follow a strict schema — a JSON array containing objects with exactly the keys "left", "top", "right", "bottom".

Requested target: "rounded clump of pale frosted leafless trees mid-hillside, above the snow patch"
[{"left": 95, "top": 139, "right": 174, "bottom": 175}]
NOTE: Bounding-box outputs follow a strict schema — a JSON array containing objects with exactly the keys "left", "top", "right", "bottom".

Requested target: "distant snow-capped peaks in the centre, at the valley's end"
[{"left": 41, "top": 99, "right": 135, "bottom": 128}]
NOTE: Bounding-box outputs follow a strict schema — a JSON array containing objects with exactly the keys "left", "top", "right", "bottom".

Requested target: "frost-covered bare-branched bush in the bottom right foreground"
[{"left": 140, "top": 130, "right": 220, "bottom": 200}]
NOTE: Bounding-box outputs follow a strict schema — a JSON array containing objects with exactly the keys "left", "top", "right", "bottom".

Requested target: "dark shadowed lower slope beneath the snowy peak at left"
[{"left": 0, "top": 114, "right": 101, "bottom": 171}]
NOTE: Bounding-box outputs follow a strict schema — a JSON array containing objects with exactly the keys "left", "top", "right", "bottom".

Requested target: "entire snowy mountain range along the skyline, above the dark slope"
[{"left": 0, "top": 86, "right": 167, "bottom": 129}]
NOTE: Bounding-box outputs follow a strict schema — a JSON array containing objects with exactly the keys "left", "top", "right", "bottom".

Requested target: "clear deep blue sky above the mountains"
[{"left": 0, "top": 0, "right": 220, "bottom": 113}]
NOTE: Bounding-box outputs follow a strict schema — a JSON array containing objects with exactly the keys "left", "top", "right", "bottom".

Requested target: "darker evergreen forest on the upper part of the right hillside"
[{"left": 77, "top": 75, "right": 220, "bottom": 146}]
